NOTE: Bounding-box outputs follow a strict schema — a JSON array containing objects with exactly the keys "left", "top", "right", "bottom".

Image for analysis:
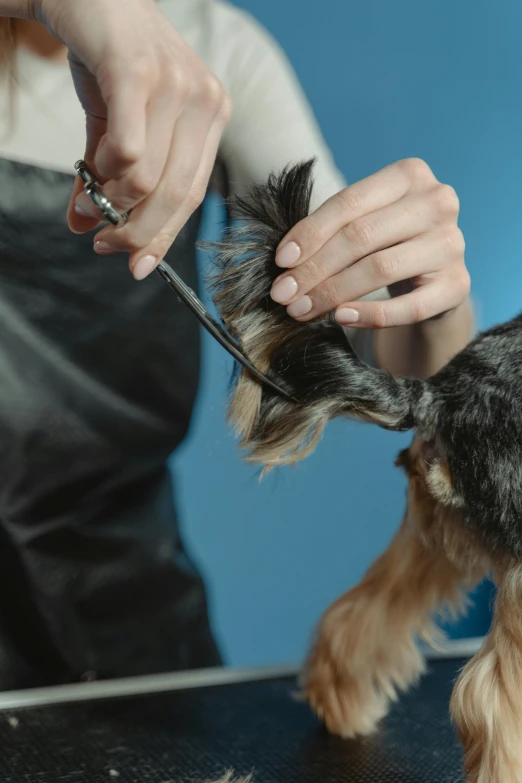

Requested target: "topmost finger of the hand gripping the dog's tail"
[{"left": 275, "top": 159, "right": 435, "bottom": 268}]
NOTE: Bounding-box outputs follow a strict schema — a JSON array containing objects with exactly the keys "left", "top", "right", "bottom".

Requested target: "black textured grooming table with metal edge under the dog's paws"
[{"left": 0, "top": 640, "right": 477, "bottom": 783}]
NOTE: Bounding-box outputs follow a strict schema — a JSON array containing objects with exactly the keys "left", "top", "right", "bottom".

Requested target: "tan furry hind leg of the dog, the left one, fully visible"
[{"left": 302, "top": 443, "right": 484, "bottom": 740}]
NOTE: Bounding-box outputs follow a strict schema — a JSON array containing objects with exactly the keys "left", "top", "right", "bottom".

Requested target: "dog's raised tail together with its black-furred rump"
[{"left": 209, "top": 161, "right": 522, "bottom": 558}]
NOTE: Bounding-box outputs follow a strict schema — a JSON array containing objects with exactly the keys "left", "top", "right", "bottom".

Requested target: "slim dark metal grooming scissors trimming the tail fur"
[{"left": 74, "top": 160, "right": 295, "bottom": 402}]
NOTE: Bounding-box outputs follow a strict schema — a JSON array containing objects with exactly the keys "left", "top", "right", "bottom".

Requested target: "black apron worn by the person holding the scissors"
[{"left": 0, "top": 159, "right": 220, "bottom": 690}]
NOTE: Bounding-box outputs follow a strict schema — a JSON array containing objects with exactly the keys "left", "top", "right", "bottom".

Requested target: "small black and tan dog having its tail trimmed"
[{"left": 212, "top": 161, "right": 522, "bottom": 783}]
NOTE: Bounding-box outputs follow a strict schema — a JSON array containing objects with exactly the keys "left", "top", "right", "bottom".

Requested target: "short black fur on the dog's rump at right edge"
[{"left": 429, "top": 316, "right": 522, "bottom": 558}]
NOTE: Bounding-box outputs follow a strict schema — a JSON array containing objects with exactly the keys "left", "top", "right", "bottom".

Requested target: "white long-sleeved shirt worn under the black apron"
[{"left": 0, "top": 0, "right": 386, "bottom": 358}]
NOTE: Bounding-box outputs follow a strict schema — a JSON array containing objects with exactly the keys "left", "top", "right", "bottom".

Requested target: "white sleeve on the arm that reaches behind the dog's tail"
[{"left": 198, "top": 2, "right": 388, "bottom": 364}]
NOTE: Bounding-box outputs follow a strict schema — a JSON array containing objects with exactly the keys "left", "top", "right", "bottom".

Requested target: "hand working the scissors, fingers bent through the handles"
[{"left": 31, "top": 0, "right": 230, "bottom": 279}]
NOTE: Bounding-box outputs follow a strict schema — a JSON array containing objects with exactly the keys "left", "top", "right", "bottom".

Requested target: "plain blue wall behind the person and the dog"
[{"left": 172, "top": 0, "right": 522, "bottom": 665}]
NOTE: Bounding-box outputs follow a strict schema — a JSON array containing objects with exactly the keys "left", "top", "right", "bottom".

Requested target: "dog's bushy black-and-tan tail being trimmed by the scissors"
[{"left": 212, "top": 161, "right": 424, "bottom": 467}]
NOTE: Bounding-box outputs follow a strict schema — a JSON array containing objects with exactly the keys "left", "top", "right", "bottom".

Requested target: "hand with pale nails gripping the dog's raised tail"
[{"left": 271, "top": 159, "right": 470, "bottom": 329}]
